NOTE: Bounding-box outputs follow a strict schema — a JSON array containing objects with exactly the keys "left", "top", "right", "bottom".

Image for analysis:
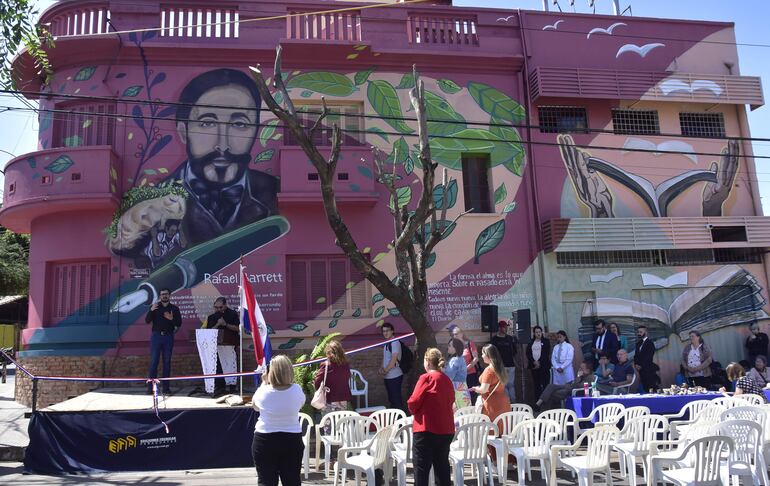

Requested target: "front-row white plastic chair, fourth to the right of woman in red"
[{"left": 613, "top": 414, "right": 668, "bottom": 486}]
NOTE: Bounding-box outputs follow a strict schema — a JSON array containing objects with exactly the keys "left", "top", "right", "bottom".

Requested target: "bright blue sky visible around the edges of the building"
[{"left": 0, "top": 0, "right": 770, "bottom": 215}]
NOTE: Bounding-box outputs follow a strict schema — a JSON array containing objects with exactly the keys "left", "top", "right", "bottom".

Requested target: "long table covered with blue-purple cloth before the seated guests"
[{"left": 566, "top": 392, "right": 720, "bottom": 418}]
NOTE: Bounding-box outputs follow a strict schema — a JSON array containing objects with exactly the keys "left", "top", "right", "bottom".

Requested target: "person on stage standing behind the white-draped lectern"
[{"left": 203, "top": 297, "right": 241, "bottom": 396}]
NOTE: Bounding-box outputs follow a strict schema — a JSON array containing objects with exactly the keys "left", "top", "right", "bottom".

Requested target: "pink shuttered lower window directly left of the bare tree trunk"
[{"left": 287, "top": 255, "right": 371, "bottom": 319}]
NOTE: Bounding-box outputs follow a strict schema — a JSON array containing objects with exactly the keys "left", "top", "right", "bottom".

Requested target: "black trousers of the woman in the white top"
[{"left": 251, "top": 432, "right": 305, "bottom": 486}]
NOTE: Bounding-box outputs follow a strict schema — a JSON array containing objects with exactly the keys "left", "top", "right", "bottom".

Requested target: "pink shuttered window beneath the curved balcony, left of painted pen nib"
[{"left": 46, "top": 258, "right": 110, "bottom": 322}]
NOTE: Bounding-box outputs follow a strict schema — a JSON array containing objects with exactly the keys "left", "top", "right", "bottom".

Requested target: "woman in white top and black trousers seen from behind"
[{"left": 251, "top": 355, "right": 305, "bottom": 486}]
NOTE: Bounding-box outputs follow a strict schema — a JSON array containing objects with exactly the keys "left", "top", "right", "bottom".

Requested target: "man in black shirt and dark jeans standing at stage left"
[{"left": 144, "top": 289, "right": 182, "bottom": 394}]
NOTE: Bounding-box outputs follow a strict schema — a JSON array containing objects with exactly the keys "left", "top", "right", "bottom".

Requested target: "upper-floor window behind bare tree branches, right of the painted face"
[{"left": 284, "top": 103, "right": 365, "bottom": 146}]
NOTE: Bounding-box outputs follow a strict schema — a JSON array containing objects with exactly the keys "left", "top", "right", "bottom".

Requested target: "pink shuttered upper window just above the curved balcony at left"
[{"left": 51, "top": 103, "right": 115, "bottom": 148}]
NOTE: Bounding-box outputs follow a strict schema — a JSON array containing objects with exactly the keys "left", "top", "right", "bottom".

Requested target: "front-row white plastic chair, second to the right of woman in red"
[{"left": 502, "top": 418, "right": 560, "bottom": 486}]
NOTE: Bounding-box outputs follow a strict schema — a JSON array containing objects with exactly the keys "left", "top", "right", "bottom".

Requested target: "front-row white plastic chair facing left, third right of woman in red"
[{"left": 550, "top": 425, "right": 620, "bottom": 486}]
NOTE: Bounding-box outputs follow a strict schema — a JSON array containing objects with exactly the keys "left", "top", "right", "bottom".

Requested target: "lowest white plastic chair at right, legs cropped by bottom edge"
[{"left": 650, "top": 435, "right": 735, "bottom": 486}]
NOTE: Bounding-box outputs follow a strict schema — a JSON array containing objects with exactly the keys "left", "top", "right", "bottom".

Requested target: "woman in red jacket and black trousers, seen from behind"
[{"left": 407, "top": 348, "right": 455, "bottom": 486}]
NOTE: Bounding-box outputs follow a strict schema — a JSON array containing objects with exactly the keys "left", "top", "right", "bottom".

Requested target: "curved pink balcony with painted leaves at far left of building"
[{"left": 0, "top": 145, "right": 121, "bottom": 233}]
